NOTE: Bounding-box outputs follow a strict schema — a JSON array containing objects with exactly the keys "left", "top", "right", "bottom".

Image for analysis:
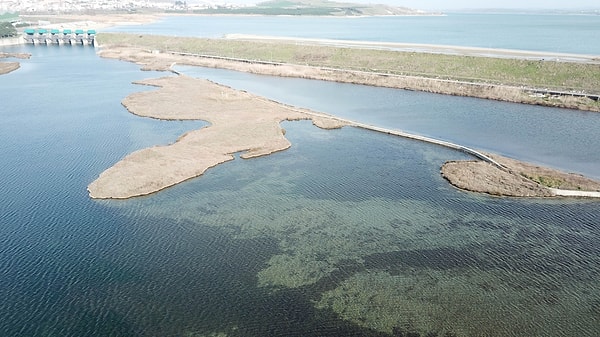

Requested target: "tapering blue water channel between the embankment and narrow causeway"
[{"left": 177, "top": 66, "right": 600, "bottom": 178}]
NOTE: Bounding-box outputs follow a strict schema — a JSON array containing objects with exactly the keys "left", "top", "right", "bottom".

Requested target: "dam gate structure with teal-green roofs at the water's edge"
[{"left": 23, "top": 28, "right": 96, "bottom": 46}]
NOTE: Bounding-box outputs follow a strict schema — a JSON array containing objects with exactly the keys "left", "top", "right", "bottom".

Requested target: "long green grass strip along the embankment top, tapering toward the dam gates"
[{"left": 97, "top": 33, "right": 600, "bottom": 94}]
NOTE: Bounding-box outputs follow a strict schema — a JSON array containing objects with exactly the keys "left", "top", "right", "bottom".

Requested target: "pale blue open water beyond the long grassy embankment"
[{"left": 111, "top": 13, "right": 600, "bottom": 55}]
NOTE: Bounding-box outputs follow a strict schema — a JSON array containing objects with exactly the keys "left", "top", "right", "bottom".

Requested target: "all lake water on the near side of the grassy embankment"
[{"left": 0, "top": 14, "right": 600, "bottom": 336}]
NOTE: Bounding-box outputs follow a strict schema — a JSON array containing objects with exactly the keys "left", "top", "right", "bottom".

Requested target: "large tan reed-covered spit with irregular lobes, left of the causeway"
[{"left": 88, "top": 76, "right": 345, "bottom": 199}]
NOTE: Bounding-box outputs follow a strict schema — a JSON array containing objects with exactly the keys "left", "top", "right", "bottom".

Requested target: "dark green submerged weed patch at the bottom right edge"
[{"left": 316, "top": 269, "right": 593, "bottom": 336}]
